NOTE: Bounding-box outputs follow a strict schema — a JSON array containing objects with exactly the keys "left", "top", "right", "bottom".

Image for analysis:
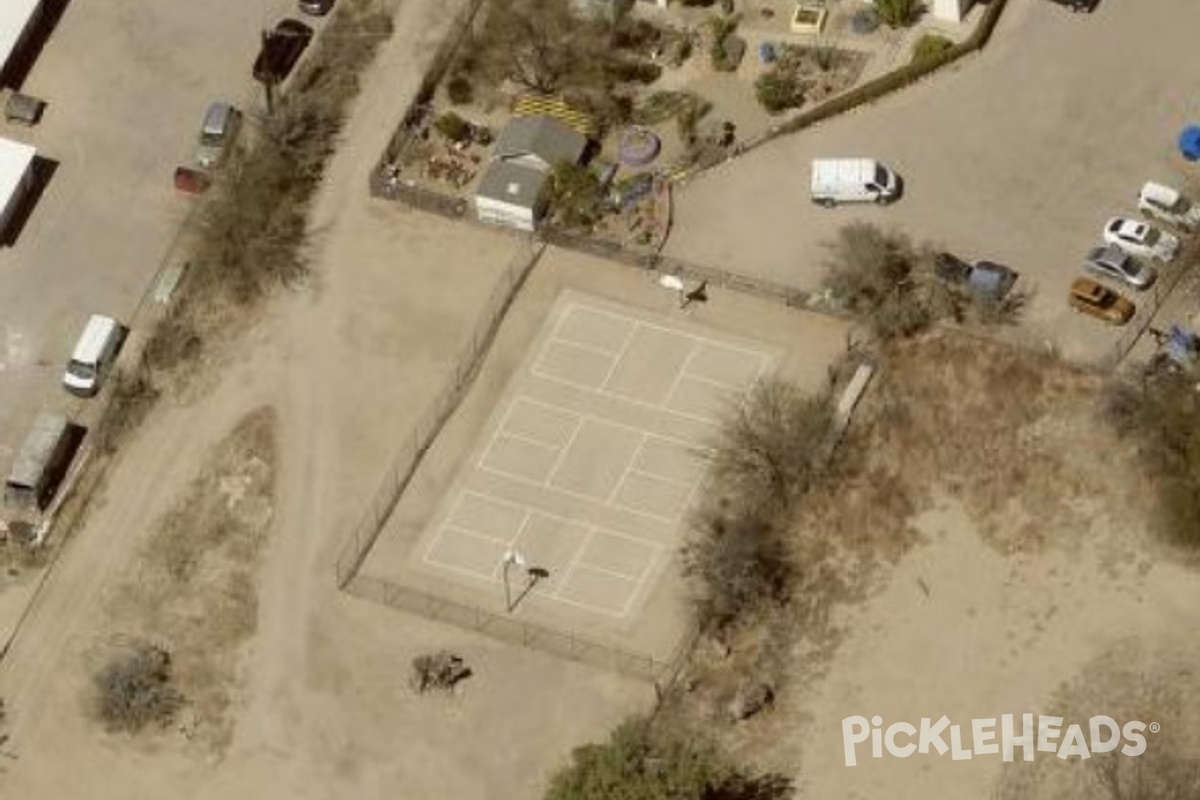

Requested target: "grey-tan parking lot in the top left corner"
[{"left": 0, "top": 0, "right": 326, "bottom": 482}]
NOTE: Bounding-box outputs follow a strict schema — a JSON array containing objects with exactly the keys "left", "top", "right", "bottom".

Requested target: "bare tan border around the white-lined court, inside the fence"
[{"left": 364, "top": 249, "right": 850, "bottom": 671}]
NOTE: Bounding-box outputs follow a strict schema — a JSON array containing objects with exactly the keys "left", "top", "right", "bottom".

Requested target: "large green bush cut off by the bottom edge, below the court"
[{"left": 545, "top": 718, "right": 791, "bottom": 800}]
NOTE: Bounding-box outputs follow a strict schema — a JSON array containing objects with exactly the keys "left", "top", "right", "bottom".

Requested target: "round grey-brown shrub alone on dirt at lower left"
[{"left": 94, "top": 644, "right": 184, "bottom": 733}]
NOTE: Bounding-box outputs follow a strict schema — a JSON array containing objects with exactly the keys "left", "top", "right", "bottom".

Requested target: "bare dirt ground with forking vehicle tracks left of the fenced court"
[{"left": 0, "top": 2, "right": 652, "bottom": 800}]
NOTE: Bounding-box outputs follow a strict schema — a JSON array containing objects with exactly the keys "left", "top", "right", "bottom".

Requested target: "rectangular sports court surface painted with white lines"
[{"left": 410, "top": 290, "right": 779, "bottom": 624}]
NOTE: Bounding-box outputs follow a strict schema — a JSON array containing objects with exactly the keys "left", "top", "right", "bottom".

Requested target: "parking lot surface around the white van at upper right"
[{"left": 667, "top": 0, "right": 1200, "bottom": 360}]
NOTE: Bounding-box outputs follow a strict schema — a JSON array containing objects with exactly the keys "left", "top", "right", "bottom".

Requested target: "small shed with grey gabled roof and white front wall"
[{"left": 475, "top": 115, "right": 588, "bottom": 230}]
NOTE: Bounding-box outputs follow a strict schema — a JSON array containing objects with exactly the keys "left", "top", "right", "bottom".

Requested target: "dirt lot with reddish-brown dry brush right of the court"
[{"left": 672, "top": 336, "right": 1200, "bottom": 800}]
